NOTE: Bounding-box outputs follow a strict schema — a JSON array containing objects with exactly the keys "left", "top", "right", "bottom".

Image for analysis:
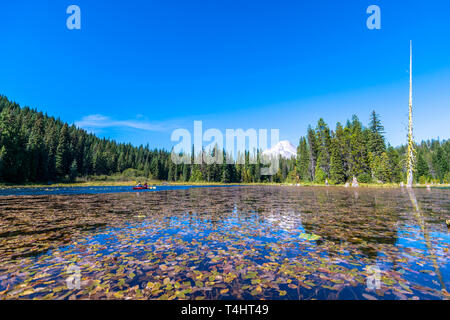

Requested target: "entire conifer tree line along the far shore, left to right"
[{"left": 0, "top": 96, "right": 450, "bottom": 184}]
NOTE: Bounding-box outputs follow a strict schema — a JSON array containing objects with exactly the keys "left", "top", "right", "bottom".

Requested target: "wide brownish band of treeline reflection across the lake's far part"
[{"left": 7, "top": 186, "right": 440, "bottom": 272}]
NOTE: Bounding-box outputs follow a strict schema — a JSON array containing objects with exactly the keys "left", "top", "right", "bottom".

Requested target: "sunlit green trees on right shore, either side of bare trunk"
[{"left": 296, "top": 111, "right": 450, "bottom": 184}]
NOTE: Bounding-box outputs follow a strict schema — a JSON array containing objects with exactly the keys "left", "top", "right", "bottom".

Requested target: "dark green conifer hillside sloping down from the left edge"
[{"left": 0, "top": 96, "right": 170, "bottom": 183}]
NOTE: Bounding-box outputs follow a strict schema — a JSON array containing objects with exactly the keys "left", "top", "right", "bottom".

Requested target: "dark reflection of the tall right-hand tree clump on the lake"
[{"left": 301, "top": 189, "right": 399, "bottom": 259}]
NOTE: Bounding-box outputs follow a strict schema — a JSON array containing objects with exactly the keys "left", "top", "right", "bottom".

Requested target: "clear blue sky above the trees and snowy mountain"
[{"left": 0, "top": 0, "right": 450, "bottom": 149}]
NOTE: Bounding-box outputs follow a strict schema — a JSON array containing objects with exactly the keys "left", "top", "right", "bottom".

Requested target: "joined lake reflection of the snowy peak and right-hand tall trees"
[{"left": 227, "top": 187, "right": 400, "bottom": 259}]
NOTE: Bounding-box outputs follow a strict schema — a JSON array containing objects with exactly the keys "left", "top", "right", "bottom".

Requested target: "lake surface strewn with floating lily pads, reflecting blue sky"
[{"left": 0, "top": 186, "right": 450, "bottom": 299}]
